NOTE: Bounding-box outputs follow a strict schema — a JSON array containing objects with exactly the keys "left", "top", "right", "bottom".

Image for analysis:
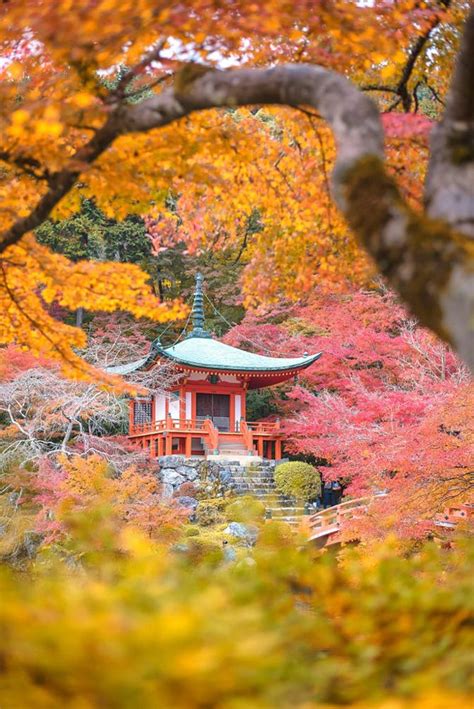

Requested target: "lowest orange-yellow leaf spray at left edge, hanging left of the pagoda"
[{"left": 0, "top": 236, "right": 186, "bottom": 388}]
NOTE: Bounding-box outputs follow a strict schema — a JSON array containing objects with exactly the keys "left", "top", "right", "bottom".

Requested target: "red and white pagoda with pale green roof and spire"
[{"left": 108, "top": 274, "right": 321, "bottom": 460}]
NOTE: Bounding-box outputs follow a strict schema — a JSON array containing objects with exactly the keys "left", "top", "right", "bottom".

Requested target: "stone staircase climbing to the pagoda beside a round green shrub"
[{"left": 229, "top": 460, "right": 305, "bottom": 524}]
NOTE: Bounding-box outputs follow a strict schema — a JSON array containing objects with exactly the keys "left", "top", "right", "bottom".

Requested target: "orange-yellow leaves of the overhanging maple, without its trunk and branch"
[{"left": 0, "top": 0, "right": 466, "bottom": 376}]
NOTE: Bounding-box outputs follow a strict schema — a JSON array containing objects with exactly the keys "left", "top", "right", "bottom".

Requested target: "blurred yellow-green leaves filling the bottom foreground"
[{"left": 0, "top": 519, "right": 474, "bottom": 709}]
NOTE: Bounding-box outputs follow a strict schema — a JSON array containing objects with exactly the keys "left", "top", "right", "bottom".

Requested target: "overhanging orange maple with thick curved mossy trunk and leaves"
[{"left": 0, "top": 0, "right": 474, "bottom": 374}]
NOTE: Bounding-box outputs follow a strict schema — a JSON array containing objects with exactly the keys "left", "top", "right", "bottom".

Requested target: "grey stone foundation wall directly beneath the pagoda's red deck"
[{"left": 158, "top": 455, "right": 283, "bottom": 497}]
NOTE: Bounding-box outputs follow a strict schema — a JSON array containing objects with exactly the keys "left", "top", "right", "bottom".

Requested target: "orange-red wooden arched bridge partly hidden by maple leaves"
[{"left": 308, "top": 492, "right": 474, "bottom": 548}]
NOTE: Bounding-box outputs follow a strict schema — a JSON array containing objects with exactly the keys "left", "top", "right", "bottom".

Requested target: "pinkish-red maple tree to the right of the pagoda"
[{"left": 225, "top": 289, "right": 474, "bottom": 539}]
